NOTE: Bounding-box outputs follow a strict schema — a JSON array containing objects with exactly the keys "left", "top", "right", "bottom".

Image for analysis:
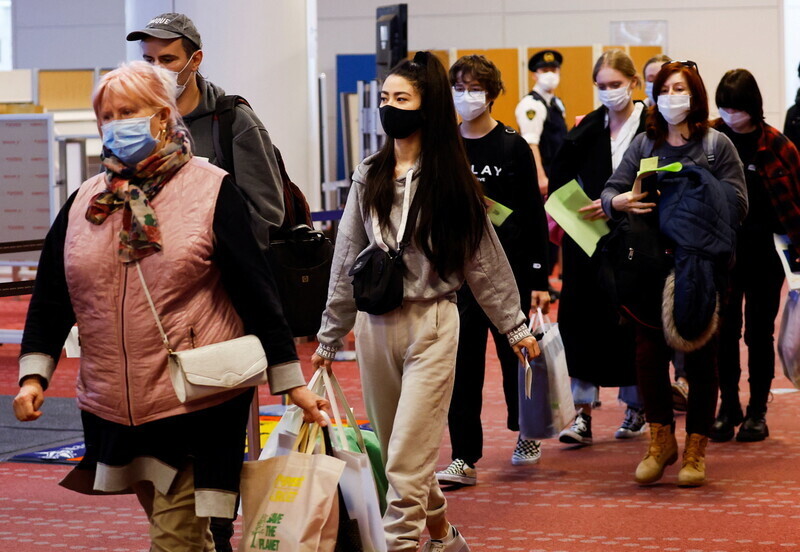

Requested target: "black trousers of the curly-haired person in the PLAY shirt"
[{"left": 447, "top": 286, "right": 531, "bottom": 464}]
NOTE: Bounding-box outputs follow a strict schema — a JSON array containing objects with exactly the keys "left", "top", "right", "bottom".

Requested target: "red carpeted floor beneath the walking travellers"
[{"left": 0, "top": 299, "right": 800, "bottom": 552}]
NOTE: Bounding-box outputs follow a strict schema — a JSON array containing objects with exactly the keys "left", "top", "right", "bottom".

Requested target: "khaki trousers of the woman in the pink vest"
[{"left": 134, "top": 464, "right": 214, "bottom": 552}]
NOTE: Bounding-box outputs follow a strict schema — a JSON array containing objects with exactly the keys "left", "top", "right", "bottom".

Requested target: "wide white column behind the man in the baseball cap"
[{"left": 162, "top": 0, "right": 319, "bottom": 209}]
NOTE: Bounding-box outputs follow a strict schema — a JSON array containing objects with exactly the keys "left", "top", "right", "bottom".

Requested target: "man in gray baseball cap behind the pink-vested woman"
[{"left": 127, "top": 13, "right": 284, "bottom": 251}]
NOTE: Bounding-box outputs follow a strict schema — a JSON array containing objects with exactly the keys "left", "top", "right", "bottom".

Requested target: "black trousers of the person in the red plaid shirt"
[{"left": 719, "top": 239, "right": 784, "bottom": 416}]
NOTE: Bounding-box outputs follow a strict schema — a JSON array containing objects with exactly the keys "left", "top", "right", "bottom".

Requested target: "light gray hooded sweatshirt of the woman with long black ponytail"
[{"left": 317, "top": 158, "right": 530, "bottom": 359}]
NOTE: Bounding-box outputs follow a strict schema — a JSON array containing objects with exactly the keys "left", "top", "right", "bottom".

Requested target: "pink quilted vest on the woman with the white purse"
[{"left": 64, "top": 158, "right": 246, "bottom": 425}]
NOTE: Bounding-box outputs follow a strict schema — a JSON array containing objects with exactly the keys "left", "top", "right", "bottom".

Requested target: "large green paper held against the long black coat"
[{"left": 544, "top": 180, "right": 609, "bottom": 257}]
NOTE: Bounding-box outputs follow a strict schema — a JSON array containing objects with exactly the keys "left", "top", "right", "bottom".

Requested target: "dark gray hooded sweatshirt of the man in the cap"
[{"left": 183, "top": 75, "right": 283, "bottom": 251}]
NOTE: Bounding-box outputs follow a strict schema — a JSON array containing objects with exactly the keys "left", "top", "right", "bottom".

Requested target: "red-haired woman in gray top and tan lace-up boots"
[{"left": 602, "top": 61, "right": 747, "bottom": 486}]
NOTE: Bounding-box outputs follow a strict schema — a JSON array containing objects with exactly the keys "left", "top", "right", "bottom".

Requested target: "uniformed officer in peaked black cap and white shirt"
[{"left": 514, "top": 50, "right": 567, "bottom": 195}]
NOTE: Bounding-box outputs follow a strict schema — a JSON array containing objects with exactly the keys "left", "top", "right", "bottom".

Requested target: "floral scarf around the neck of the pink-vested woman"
[{"left": 86, "top": 129, "right": 192, "bottom": 263}]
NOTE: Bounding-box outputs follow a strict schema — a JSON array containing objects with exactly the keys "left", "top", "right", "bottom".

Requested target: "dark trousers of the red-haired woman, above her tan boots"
[{"left": 636, "top": 324, "right": 719, "bottom": 436}]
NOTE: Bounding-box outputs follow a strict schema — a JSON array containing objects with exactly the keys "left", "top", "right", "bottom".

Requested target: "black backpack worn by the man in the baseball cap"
[{"left": 212, "top": 96, "right": 333, "bottom": 337}]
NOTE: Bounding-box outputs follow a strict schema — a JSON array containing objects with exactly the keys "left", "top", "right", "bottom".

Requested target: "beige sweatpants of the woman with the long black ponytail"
[{"left": 354, "top": 300, "right": 459, "bottom": 552}]
